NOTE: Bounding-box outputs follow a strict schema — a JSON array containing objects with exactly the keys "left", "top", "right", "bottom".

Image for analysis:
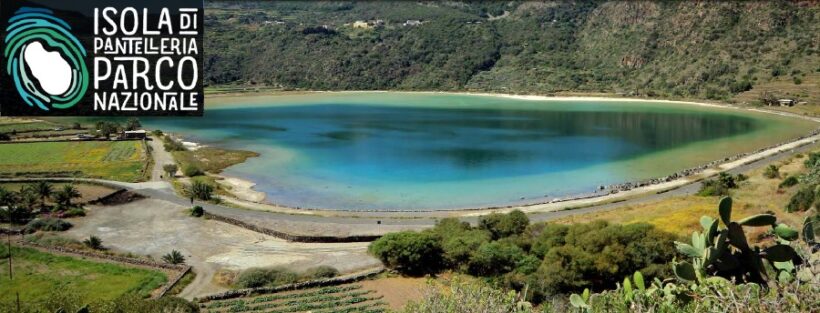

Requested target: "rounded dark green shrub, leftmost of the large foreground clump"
[{"left": 368, "top": 231, "right": 442, "bottom": 275}]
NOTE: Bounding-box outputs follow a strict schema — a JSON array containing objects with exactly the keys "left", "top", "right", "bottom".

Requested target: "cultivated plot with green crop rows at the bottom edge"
[{"left": 200, "top": 284, "right": 387, "bottom": 313}]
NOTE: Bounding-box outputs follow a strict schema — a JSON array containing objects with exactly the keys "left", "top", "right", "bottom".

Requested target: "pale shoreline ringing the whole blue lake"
[{"left": 175, "top": 91, "right": 820, "bottom": 215}]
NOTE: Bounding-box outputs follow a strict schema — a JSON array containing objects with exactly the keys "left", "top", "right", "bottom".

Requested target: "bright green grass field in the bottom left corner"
[{"left": 0, "top": 245, "right": 167, "bottom": 303}]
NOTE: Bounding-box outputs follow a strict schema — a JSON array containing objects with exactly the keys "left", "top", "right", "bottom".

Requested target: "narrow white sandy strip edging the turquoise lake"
[{"left": 194, "top": 91, "right": 820, "bottom": 216}]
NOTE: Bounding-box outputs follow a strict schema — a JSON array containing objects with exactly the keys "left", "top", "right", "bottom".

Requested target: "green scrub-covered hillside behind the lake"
[{"left": 205, "top": 1, "right": 820, "bottom": 102}]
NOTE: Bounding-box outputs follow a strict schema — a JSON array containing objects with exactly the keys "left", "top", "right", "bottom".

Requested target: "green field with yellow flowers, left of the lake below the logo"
[{"left": 0, "top": 141, "right": 148, "bottom": 182}]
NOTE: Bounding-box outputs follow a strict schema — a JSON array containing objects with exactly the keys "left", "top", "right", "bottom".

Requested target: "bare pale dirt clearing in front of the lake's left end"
[{"left": 65, "top": 199, "right": 380, "bottom": 299}]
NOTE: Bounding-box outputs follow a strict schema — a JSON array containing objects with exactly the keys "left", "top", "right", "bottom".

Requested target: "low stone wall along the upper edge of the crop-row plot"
[{"left": 194, "top": 266, "right": 384, "bottom": 303}]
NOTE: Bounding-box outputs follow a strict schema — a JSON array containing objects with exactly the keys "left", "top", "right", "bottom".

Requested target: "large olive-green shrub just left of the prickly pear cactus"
[{"left": 531, "top": 221, "right": 675, "bottom": 299}]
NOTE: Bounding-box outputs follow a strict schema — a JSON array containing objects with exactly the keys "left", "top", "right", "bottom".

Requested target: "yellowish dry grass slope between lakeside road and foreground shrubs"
[{"left": 556, "top": 151, "right": 816, "bottom": 239}]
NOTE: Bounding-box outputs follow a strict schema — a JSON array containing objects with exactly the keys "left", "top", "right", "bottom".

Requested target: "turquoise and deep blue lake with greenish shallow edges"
[{"left": 144, "top": 92, "right": 816, "bottom": 211}]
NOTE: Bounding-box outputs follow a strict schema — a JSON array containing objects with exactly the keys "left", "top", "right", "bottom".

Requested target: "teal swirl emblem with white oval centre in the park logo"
[{"left": 3, "top": 7, "right": 88, "bottom": 111}]
